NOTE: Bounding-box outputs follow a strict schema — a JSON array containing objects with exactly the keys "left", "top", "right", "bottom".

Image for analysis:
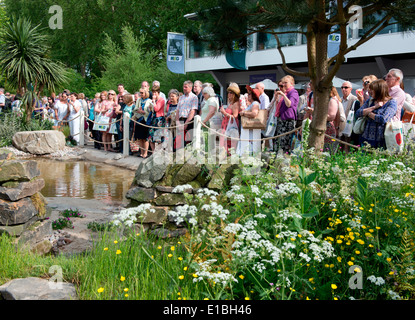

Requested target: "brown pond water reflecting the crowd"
[{"left": 36, "top": 159, "right": 134, "bottom": 204}]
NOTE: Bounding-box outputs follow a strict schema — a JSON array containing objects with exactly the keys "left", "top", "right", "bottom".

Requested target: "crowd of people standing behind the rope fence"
[{"left": 0, "top": 69, "right": 415, "bottom": 158}]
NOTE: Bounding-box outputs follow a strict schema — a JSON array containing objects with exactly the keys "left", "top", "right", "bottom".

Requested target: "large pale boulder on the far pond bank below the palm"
[{"left": 13, "top": 130, "right": 65, "bottom": 155}]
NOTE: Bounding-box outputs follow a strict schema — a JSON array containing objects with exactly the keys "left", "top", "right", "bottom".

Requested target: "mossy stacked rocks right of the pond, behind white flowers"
[{"left": 126, "top": 151, "right": 238, "bottom": 238}]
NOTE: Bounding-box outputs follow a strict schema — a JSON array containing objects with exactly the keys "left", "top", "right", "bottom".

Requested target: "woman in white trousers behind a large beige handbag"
[{"left": 238, "top": 86, "right": 261, "bottom": 156}]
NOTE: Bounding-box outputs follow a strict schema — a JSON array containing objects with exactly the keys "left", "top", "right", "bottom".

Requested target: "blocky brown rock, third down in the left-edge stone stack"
[{"left": 0, "top": 198, "right": 38, "bottom": 226}]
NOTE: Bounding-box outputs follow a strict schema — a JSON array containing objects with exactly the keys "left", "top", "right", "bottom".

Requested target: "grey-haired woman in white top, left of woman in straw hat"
[{"left": 200, "top": 86, "right": 219, "bottom": 151}]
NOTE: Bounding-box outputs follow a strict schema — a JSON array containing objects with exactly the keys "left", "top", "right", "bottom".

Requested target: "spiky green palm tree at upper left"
[{"left": 0, "top": 17, "right": 67, "bottom": 119}]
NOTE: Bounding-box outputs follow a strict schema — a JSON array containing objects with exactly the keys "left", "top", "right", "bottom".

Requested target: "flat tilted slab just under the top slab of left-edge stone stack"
[{"left": 0, "top": 178, "right": 45, "bottom": 201}]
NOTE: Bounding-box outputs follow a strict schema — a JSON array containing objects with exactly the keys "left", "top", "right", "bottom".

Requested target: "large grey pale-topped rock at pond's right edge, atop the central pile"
[{"left": 133, "top": 150, "right": 173, "bottom": 188}]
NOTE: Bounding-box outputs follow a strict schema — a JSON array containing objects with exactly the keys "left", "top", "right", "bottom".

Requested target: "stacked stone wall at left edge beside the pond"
[{"left": 0, "top": 154, "right": 52, "bottom": 250}]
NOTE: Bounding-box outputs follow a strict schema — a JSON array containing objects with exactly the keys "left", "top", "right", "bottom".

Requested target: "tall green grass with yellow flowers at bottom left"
[{"left": 0, "top": 232, "right": 206, "bottom": 300}]
